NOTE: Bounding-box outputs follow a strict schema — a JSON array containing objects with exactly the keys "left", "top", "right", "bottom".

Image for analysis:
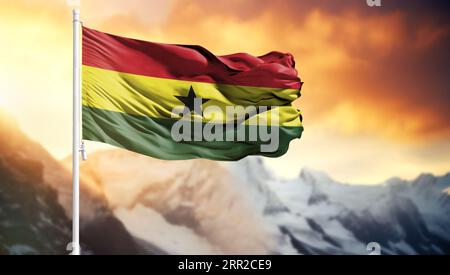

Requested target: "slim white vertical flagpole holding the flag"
[{"left": 71, "top": 7, "right": 80, "bottom": 255}]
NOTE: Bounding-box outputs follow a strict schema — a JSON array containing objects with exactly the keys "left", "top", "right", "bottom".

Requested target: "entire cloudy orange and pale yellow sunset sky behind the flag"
[{"left": 0, "top": 0, "right": 450, "bottom": 184}]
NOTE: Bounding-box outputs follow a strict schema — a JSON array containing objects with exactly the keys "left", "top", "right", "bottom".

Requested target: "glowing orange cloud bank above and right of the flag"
[{"left": 142, "top": 0, "right": 450, "bottom": 142}]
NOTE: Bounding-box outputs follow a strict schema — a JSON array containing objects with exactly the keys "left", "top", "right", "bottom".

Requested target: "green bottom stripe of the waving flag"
[{"left": 83, "top": 106, "right": 303, "bottom": 160}]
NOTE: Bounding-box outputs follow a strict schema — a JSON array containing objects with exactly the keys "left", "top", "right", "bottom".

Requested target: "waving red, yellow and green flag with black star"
[{"left": 82, "top": 27, "right": 303, "bottom": 160}]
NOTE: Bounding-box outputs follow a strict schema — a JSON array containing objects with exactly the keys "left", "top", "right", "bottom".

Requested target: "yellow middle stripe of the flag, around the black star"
[{"left": 82, "top": 65, "right": 301, "bottom": 126}]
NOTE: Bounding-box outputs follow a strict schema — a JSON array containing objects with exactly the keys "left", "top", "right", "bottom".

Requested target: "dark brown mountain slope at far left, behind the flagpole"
[{"left": 0, "top": 112, "right": 149, "bottom": 254}]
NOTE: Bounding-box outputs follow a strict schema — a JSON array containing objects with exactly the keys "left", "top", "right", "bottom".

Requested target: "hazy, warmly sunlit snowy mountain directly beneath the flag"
[{"left": 81, "top": 150, "right": 272, "bottom": 254}]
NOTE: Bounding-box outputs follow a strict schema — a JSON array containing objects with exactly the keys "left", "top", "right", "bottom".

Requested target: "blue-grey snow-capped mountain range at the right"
[{"left": 230, "top": 158, "right": 450, "bottom": 254}]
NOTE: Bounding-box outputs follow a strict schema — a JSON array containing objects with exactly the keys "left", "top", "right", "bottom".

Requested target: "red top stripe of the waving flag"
[{"left": 83, "top": 27, "right": 301, "bottom": 89}]
